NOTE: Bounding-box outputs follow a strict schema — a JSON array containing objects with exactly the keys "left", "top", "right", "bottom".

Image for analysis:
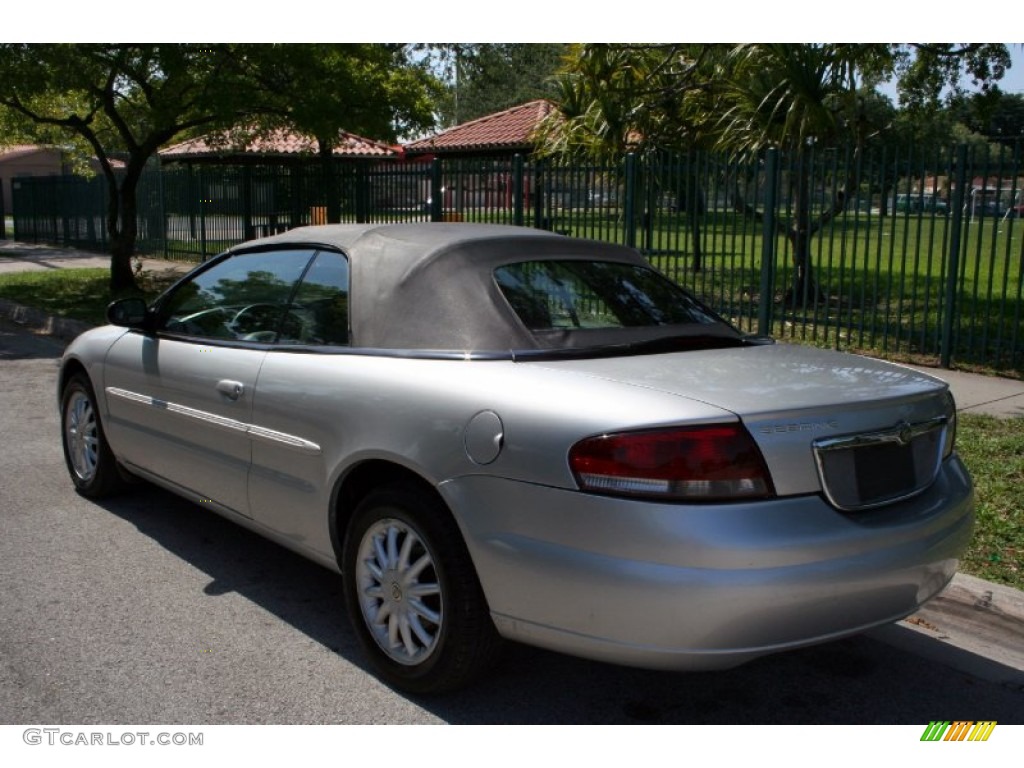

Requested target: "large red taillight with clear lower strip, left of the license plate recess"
[{"left": 569, "top": 424, "right": 775, "bottom": 502}]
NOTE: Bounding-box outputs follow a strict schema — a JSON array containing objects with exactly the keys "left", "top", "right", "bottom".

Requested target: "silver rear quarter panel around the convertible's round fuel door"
[{"left": 243, "top": 353, "right": 734, "bottom": 553}]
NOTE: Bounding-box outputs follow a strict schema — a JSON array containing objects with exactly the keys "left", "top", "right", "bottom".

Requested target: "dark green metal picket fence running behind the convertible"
[{"left": 11, "top": 146, "right": 1024, "bottom": 373}]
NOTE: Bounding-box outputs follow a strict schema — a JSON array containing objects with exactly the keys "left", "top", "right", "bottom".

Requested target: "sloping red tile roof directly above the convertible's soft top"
[{"left": 406, "top": 99, "right": 554, "bottom": 154}]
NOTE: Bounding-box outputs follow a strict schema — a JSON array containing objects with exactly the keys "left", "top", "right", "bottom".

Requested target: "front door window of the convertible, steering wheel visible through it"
[{"left": 160, "top": 249, "right": 312, "bottom": 343}]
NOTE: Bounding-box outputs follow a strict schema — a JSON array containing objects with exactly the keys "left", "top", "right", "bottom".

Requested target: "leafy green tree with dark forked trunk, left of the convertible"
[{"left": 0, "top": 43, "right": 440, "bottom": 293}]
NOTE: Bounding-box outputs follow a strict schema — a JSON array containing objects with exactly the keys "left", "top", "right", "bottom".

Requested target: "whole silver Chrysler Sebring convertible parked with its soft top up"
[{"left": 59, "top": 223, "right": 974, "bottom": 692}]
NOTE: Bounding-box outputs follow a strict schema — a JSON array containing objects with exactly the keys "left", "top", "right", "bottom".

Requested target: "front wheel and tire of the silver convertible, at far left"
[{"left": 60, "top": 374, "right": 125, "bottom": 499}]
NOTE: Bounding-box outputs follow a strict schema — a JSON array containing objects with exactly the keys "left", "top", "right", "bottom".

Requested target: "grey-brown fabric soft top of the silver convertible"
[{"left": 231, "top": 223, "right": 649, "bottom": 352}]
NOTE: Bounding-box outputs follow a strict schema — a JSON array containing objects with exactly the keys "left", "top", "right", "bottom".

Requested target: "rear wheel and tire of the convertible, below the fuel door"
[{"left": 342, "top": 487, "right": 501, "bottom": 693}]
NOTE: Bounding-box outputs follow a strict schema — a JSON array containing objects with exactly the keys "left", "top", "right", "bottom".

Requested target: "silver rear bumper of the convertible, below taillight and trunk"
[{"left": 441, "top": 458, "right": 974, "bottom": 670}]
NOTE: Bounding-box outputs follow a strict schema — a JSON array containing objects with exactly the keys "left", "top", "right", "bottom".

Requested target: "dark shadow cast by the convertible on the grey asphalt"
[{"left": 96, "top": 484, "right": 1024, "bottom": 727}]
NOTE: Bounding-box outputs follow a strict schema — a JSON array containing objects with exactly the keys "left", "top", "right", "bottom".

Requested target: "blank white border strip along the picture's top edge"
[{"left": 8, "top": 0, "right": 1024, "bottom": 47}]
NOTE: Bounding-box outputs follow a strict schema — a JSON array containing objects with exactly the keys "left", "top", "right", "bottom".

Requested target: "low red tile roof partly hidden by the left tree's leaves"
[{"left": 160, "top": 129, "right": 401, "bottom": 160}]
